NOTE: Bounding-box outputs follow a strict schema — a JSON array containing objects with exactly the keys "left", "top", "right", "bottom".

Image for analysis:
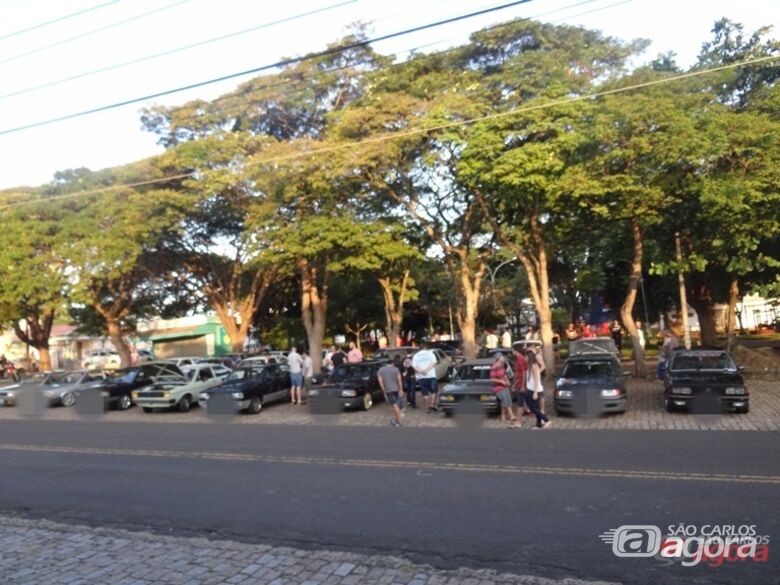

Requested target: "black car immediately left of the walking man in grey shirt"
[{"left": 309, "top": 360, "right": 388, "bottom": 413}]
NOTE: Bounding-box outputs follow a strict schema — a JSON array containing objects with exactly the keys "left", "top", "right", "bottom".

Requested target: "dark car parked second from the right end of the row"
[{"left": 553, "top": 353, "right": 626, "bottom": 416}]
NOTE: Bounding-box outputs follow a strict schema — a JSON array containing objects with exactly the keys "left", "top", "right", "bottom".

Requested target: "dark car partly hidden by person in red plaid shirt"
[{"left": 439, "top": 358, "right": 502, "bottom": 414}]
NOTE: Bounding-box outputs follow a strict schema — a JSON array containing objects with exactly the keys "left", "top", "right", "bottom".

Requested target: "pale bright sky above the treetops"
[{"left": 0, "top": 0, "right": 780, "bottom": 189}]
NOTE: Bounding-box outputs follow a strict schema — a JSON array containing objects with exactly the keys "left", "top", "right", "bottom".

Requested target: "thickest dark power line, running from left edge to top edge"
[{"left": 0, "top": 0, "right": 532, "bottom": 136}]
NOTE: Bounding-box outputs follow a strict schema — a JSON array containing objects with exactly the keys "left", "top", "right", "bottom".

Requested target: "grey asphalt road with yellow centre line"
[{"left": 0, "top": 421, "right": 780, "bottom": 584}]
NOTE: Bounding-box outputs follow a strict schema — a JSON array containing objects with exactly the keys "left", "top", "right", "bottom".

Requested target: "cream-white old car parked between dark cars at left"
[{"left": 132, "top": 363, "right": 231, "bottom": 413}]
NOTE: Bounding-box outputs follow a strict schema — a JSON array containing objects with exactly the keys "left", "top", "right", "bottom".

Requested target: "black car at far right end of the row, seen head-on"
[{"left": 664, "top": 349, "right": 750, "bottom": 414}]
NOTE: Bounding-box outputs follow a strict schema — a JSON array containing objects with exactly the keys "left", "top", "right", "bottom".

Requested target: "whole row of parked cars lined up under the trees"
[{"left": 0, "top": 338, "right": 750, "bottom": 416}]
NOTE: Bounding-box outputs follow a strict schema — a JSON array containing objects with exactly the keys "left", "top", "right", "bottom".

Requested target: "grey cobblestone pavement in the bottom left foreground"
[{"left": 0, "top": 516, "right": 608, "bottom": 585}]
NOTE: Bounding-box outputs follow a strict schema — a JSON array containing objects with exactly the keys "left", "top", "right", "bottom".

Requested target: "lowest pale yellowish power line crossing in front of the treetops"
[{"left": 0, "top": 55, "right": 780, "bottom": 209}]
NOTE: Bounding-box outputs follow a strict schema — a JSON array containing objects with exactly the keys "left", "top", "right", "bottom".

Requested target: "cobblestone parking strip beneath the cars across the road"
[{"left": 0, "top": 379, "right": 780, "bottom": 431}]
